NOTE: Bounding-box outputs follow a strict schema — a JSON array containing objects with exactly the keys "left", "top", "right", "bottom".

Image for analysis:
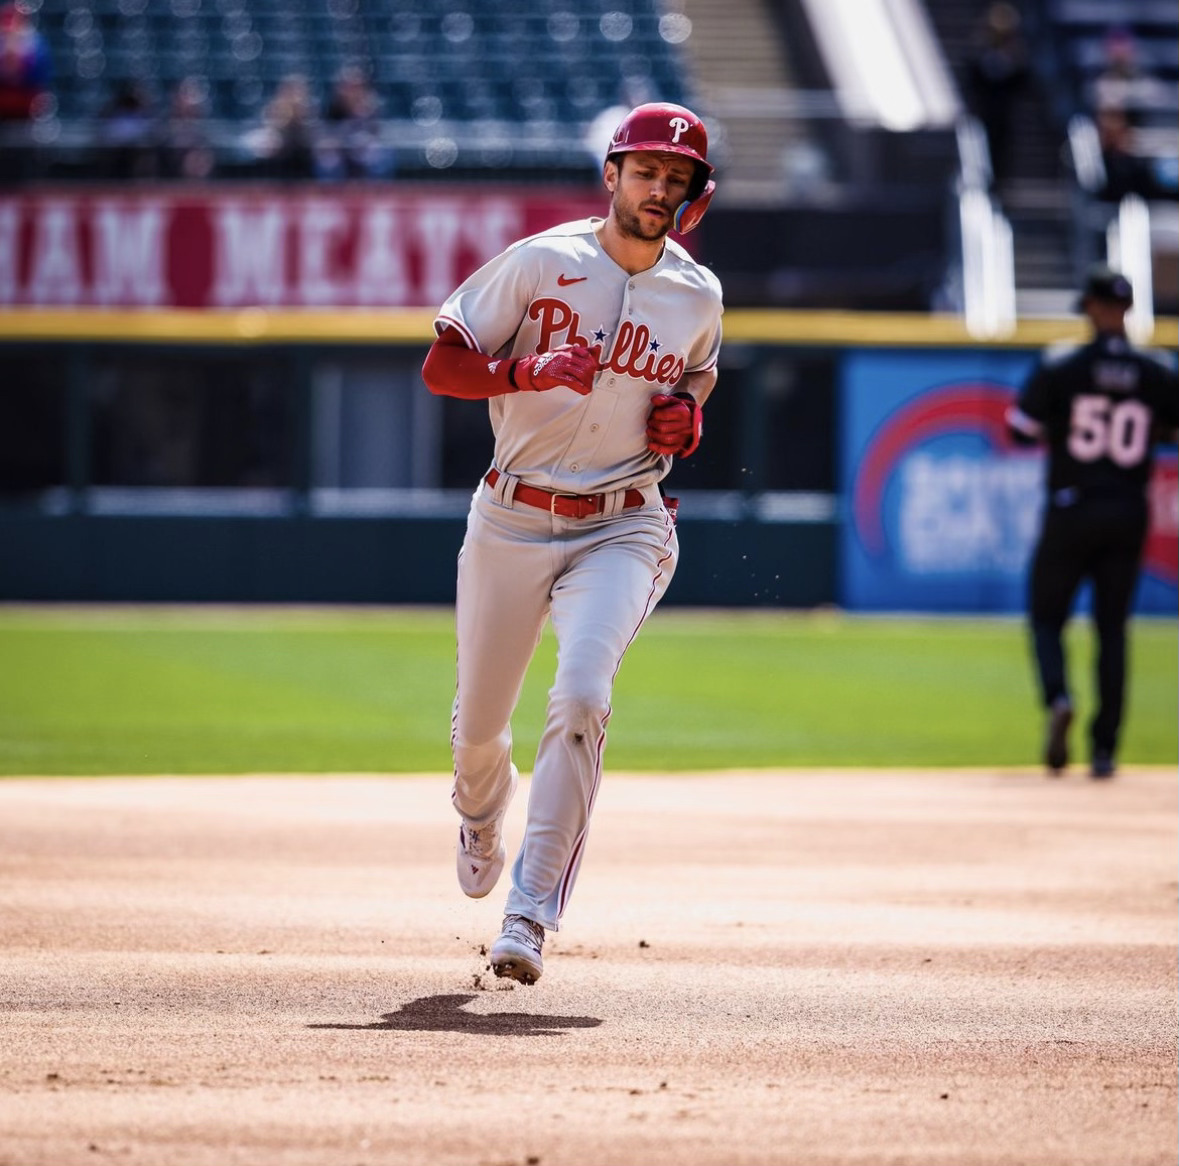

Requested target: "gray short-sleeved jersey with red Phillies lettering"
[{"left": 434, "top": 218, "right": 723, "bottom": 494}]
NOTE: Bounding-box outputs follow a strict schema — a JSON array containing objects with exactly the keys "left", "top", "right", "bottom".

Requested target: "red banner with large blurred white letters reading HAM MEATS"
[{"left": 0, "top": 186, "right": 607, "bottom": 308}]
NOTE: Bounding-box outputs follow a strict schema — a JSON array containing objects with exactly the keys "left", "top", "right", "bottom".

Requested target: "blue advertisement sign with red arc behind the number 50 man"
[{"left": 841, "top": 349, "right": 1177, "bottom": 614}]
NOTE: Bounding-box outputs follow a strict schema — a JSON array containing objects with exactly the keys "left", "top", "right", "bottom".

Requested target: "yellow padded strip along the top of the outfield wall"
[{"left": 0, "top": 308, "right": 1179, "bottom": 348}]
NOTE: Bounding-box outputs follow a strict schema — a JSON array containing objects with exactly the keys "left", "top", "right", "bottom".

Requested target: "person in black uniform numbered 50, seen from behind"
[{"left": 1007, "top": 266, "right": 1179, "bottom": 778}]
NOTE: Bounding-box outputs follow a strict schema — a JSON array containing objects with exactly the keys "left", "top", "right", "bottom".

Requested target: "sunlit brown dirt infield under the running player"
[{"left": 0, "top": 770, "right": 1179, "bottom": 1166}]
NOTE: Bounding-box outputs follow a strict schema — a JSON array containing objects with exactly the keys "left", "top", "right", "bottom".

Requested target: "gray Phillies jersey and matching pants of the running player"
[{"left": 435, "top": 211, "right": 722, "bottom": 929}]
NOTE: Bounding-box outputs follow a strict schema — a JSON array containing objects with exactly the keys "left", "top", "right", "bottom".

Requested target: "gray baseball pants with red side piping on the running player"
[{"left": 452, "top": 475, "right": 679, "bottom": 931}]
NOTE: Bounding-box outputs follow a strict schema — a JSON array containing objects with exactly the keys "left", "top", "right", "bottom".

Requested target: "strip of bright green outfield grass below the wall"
[{"left": 0, "top": 607, "right": 1179, "bottom": 775}]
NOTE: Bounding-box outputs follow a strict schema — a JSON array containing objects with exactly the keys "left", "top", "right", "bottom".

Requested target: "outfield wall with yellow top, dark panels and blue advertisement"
[{"left": 0, "top": 309, "right": 1179, "bottom": 614}]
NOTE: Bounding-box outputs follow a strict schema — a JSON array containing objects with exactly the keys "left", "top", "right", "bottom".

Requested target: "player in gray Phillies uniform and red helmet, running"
[{"left": 422, "top": 104, "right": 723, "bottom": 983}]
